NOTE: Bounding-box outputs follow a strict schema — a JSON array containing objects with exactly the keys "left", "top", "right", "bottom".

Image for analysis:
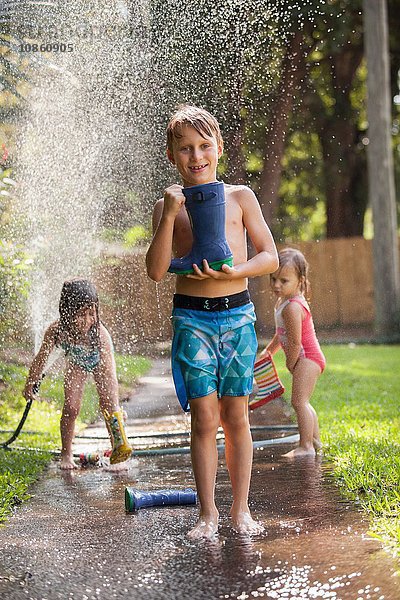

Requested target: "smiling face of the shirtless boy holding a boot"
[{"left": 167, "top": 125, "right": 222, "bottom": 187}]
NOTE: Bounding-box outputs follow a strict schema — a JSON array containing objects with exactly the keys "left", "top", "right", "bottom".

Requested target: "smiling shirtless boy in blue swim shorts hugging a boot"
[{"left": 146, "top": 105, "right": 278, "bottom": 539}]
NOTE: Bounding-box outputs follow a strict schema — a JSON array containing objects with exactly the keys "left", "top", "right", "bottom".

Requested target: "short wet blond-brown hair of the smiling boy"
[{"left": 167, "top": 104, "right": 223, "bottom": 152}]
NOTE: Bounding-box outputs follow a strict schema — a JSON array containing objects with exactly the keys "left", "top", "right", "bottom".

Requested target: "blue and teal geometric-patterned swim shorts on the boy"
[{"left": 171, "top": 297, "right": 257, "bottom": 411}]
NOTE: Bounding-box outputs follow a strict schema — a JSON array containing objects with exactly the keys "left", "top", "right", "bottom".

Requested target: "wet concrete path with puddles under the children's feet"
[{"left": 0, "top": 360, "right": 400, "bottom": 600}]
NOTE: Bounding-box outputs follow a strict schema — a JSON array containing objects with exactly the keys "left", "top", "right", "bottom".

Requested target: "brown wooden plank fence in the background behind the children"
[{"left": 95, "top": 237, "right": 374, "bottom": 349}]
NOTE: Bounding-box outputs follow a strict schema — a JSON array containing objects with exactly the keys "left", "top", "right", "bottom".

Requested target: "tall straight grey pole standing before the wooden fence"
[{"left": 363, "top": 0, "right": 400, "bottom": 336}]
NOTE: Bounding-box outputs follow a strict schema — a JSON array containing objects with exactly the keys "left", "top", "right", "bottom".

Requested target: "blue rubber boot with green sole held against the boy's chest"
[{"left": 168, "top": 181, "right": 233, "bottom": 275}]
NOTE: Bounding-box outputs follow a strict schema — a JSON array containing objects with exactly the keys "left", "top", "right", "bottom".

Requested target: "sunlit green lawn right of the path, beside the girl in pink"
[{"left": 276, "top": 344, "right": 400, "bottom": 556}]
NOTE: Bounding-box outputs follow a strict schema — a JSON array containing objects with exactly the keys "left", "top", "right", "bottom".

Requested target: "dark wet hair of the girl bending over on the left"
[{"left": 58, "top": 277, "right": 100, "bottom": 346}]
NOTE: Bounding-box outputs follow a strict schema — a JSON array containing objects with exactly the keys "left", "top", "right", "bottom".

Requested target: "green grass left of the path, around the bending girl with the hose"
[{"left": 0, "top": 355, "right": 150, "bottom": 522}]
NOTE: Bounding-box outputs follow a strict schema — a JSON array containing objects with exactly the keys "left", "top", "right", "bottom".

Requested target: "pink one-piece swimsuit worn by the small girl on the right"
[{"left": 275, "top": 296, "right": 326, "bottom": 373}]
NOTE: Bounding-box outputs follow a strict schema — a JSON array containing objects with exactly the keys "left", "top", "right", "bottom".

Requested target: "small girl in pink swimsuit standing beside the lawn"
[{"left": 262, "top": 248, "right": 326, "bottom": 458}]
